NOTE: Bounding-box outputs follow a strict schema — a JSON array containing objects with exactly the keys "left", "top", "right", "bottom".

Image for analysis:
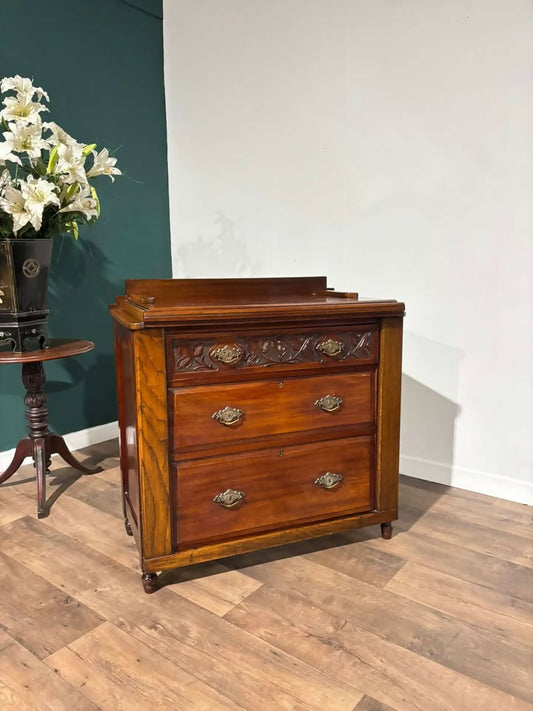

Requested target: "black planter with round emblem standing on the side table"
[{"left": 0, "top": 239, "right": 53, "bottom": 353}]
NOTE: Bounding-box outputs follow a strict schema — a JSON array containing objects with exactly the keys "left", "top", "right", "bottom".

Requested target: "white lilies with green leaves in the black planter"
[{"left": 0, "top": 75, "right": 121, "bottom": 239}]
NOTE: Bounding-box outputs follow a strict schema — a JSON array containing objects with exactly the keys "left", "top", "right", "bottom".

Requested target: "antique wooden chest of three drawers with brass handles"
[{"left": 111, "top": 277, "right": 404, "bottom": 592}]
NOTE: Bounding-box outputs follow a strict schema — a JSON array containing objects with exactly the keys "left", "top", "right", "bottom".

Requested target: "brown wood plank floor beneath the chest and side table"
[{"left": 0, "top": 441, "right": 533, "bottom": 711}]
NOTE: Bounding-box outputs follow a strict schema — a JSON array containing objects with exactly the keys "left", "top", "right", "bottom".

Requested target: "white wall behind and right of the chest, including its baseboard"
[{"left": 164, "top": 0, "right": 533, "bottom": 502}]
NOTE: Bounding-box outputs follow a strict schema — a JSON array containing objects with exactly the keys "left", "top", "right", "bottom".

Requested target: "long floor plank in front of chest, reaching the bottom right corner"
[{"left": 225, "top": 581, "right": 530, "bottom": 711}]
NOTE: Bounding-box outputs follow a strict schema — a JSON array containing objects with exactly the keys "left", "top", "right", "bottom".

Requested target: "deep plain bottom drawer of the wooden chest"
[{"left": 174, "top": 436, "right": 374, "bottom": 549}]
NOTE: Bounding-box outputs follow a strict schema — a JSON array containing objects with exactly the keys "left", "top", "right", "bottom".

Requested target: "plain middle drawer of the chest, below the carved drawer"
[{"left": 169, "top": 370, "right": 375, "bottom": 452}]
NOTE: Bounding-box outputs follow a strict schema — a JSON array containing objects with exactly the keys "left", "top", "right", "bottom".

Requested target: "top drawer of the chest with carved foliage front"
[{"left": 166, "top": 323, "right": 379, "bottom": 384}]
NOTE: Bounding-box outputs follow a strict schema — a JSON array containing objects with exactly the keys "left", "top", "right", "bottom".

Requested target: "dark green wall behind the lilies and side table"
[{"left": 0, "top": 0, "right": 171, "bottom": 451}]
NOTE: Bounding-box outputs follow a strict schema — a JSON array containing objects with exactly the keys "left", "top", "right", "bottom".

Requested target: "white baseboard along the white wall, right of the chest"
[{"left": 400, "top": 455, "right": 533, "bottom": 506}]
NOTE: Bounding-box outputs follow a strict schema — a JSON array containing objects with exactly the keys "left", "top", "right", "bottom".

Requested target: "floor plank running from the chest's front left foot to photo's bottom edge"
[{"left": 116, "top": 591, "right": 362, "bottom": 711}]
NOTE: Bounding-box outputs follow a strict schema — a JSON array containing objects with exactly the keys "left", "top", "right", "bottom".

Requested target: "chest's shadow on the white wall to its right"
[{"left": 401, "top": 374, "right": 459, "bottom": 484}]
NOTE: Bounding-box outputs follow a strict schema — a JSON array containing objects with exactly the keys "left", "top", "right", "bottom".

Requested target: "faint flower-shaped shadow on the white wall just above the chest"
[{"left": 174, "top": 212, "right": 259, "bottom": 278}]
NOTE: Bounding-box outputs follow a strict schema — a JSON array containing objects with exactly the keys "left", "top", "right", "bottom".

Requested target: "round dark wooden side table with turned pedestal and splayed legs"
[{"left": 0, "top": 339, "right": 102, "bottom": 518}]
